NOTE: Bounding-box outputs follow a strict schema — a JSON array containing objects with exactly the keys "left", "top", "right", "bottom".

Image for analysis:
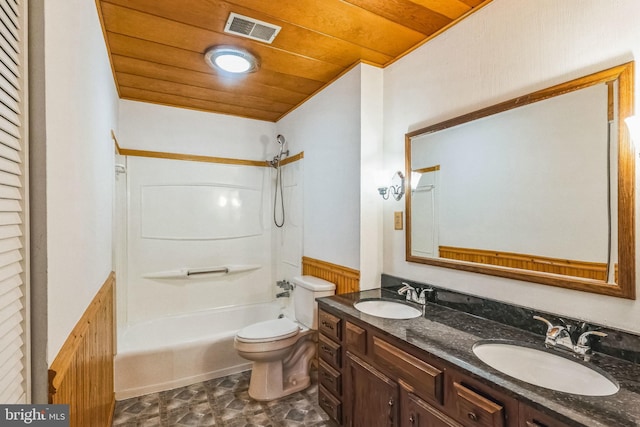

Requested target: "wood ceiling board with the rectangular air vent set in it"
[{"left": 101, "top": 0, "right": 393, "bottom": 67}]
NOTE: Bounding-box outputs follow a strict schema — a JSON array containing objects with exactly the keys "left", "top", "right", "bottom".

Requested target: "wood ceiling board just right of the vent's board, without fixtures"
[{"left": 222, "top": 0, "right": 425, "bottom": 58}]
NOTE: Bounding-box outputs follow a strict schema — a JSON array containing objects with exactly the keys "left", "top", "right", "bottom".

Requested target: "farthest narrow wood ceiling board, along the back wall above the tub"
[{"left": 120, "top": 86, "right": 281, "bottom": 122}]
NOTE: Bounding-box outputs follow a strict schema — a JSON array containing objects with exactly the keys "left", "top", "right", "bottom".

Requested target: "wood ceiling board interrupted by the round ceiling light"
[{"left": 107, "top": 32, "right": 344, "bottom": 83}]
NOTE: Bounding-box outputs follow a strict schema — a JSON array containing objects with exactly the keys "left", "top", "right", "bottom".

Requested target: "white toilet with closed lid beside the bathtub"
[{"left": 234, "top": 276, "right": 336, "bottom": 401}]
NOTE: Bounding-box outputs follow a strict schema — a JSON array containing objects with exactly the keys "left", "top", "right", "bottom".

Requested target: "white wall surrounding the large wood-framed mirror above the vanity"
[{"left": 384, "top": 0, "right": 640, "bottom": 332}]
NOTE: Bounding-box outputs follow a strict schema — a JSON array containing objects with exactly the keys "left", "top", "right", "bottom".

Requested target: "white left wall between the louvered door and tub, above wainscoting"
[{"left": 44, "top": 0, "right": 118, "bottom": 364}]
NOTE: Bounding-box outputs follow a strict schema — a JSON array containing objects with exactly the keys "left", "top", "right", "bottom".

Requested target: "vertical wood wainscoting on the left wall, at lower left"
[{"left": 49, "top": 272, "right": 115, "bottom": 427}]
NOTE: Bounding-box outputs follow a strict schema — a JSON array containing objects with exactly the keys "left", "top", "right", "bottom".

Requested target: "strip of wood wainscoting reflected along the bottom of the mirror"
[{"left": 439, "top": 246, "right": 617, "bottom": 281}]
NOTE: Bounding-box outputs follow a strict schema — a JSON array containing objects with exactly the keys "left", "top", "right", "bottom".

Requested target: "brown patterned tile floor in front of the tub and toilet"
[{"left": 112, "top": 369, "right": 336, "bottom": 427}]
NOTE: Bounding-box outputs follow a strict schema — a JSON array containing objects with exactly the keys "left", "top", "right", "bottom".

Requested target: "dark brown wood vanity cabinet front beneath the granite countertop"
[{"left": 318, "top": 307, "right": 567, "bottom": 427}]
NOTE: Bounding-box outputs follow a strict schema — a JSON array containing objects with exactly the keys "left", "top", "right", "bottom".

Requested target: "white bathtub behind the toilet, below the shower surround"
[{"left": 114, "top": 303, "right": 281, "bottom": 400}]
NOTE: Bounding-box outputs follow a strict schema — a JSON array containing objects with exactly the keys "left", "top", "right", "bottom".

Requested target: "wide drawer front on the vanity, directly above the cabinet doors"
[{"left": 372, "top": 336, "right": 444, "bottom": 405}]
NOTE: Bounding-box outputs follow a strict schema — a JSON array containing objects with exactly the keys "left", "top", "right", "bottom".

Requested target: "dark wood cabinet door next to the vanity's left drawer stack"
[{"left": 344, "top": 353, "right": 399, "bottom": 427}]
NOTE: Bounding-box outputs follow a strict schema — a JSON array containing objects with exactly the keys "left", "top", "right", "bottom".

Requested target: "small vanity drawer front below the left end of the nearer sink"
[{"left": 453, "top": 382, "right": 505, "bottom": 427}]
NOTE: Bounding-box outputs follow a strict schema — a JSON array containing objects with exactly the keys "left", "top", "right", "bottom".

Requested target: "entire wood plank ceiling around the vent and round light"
[{"left": 96, "top": 0, "right": 491, "bottom": 121}]
